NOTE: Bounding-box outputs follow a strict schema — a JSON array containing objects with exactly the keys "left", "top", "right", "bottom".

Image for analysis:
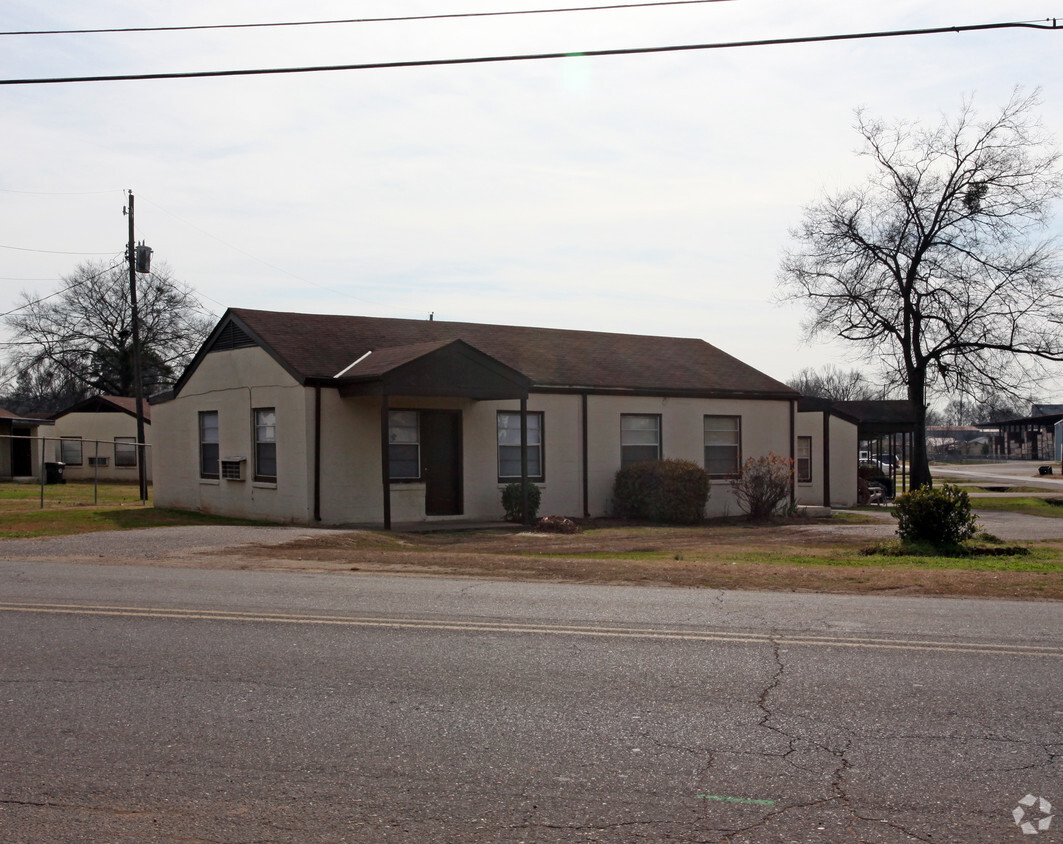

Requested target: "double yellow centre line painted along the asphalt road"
[{"left": 0, "top": 602, "right": 1063, "bottom": 657}]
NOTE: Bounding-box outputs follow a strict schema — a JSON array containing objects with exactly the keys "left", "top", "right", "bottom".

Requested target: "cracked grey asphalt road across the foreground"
[{"left": 0, "top": 561, "right": 1063, "bottom": 844}]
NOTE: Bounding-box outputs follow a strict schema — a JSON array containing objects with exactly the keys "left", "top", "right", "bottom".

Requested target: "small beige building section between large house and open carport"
[{"left": 794, "top": 396, "right": 860, "bottom": 507}]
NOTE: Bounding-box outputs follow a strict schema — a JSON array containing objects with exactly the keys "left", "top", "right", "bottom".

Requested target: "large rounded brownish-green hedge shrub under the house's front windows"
[{"left": 612, "top": 460, "right": 709, "bottom": 524}]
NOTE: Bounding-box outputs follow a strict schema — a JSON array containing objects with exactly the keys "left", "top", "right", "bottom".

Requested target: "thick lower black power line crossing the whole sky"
[{"left": 0, "top": 18, "right": 1063, "bottom": 85}]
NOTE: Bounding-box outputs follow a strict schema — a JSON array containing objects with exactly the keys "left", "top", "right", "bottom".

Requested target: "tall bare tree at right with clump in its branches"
[{"left": 779, "top": 90, "right": 1063, "bottom": 488}]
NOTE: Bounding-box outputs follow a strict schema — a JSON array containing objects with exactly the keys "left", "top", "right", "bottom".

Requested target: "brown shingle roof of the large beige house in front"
[{"left": 174, "top": 308, "right": 797, "bottom": 399}]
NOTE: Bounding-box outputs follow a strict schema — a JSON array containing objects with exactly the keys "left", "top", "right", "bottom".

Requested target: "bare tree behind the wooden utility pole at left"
[{"left": 4, "top": 259, "right": 213, "bottom": 410}]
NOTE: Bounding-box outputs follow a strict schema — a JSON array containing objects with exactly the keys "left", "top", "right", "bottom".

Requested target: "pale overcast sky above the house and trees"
[{"left": 0, "top": 0, "right": 1063, "bottom": 389}]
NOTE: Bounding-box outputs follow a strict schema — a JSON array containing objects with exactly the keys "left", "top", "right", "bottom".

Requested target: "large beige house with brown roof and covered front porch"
[{"left": 152, "top": 309, "right": 803, "bottom": 527}]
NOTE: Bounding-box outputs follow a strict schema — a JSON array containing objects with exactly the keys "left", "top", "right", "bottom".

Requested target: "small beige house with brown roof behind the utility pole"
[{"left": 50, "top": 395, "right": 152, "bottom": 482}]
